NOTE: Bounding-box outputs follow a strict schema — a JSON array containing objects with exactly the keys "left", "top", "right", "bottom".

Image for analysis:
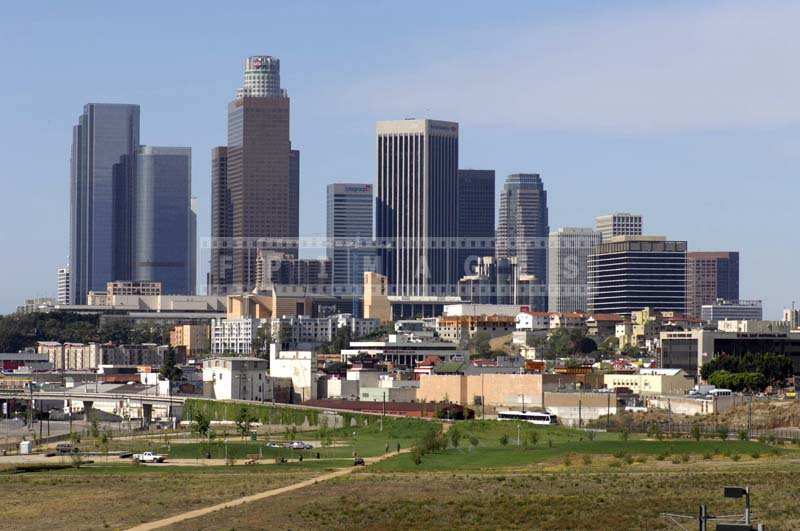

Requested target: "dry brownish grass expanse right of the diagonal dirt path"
[{"left": 164, "top": 460, "right": 800, "bottom": 529}]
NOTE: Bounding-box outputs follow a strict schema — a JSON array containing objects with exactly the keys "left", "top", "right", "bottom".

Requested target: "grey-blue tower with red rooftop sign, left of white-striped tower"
[{"left": 326, "top": 183, "right": 374, "bottom": 293}]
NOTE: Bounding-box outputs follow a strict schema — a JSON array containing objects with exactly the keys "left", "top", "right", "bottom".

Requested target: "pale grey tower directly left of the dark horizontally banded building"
[{"left": 547, "top": 227, "right": 603, "bottom": 312}]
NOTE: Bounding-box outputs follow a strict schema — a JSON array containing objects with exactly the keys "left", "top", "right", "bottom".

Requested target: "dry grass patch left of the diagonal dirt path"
[{"left": 0, "top": 466, "right": 315, "bottom": 529}]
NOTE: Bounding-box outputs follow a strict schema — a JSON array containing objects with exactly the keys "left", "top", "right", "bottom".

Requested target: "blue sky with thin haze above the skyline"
[{"left": 0, "top": 0, "right": 800, "bottom": 319}]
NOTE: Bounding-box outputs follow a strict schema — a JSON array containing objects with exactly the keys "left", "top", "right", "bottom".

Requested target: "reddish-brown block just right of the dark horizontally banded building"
[{"left": 686, "top": 252, "right": 739, "bottom": 318}]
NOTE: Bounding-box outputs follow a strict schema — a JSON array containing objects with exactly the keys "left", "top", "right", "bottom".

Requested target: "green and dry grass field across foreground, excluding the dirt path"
[{"left": 6, "top": 419, "right": 800, "bottom": 529}]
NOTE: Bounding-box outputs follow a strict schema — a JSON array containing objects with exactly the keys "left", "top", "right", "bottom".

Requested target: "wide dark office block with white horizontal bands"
[{"left": 588, "top": 236, "right": 686, "bottom": 314}]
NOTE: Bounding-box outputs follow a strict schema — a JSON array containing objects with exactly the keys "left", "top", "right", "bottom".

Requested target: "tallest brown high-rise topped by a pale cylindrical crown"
[{"left": 209, "top": 56, "right": 299, "bottom": 294}]
